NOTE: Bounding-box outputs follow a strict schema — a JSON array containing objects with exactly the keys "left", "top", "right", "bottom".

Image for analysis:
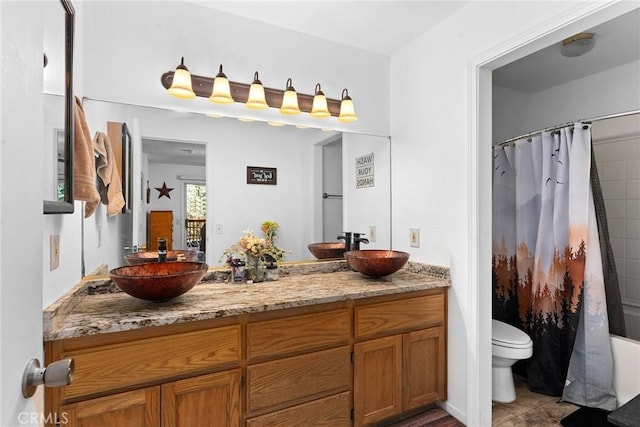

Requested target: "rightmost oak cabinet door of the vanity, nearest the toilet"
[{"left": 402, "top": 326, "right": 446, "bottom": 411}]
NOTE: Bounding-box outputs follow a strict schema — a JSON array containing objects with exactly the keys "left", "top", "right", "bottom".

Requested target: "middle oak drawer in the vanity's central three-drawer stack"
[{"left": 247, "top": 346, "right": 351, "bottom": 414}]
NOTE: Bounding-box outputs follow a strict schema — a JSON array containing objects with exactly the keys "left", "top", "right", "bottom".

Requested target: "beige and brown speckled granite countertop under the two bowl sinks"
[{"left": 43, "top": 261, "right": 450, "bottom": 341}]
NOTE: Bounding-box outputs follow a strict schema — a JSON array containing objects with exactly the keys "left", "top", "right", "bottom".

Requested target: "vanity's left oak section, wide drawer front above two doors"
[{"left": 45, "top": 325, "right": 242, "bottom": 427}]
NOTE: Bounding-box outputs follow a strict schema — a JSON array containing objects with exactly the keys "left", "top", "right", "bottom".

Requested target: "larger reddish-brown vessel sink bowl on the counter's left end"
[{"left": 109, "top": 261, "right": 209, "bottom": 302}]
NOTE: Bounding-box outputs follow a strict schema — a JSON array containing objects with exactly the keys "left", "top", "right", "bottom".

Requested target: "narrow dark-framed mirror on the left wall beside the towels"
[{"left": 43, "top": 0, "right": 75, "bottom": 214}]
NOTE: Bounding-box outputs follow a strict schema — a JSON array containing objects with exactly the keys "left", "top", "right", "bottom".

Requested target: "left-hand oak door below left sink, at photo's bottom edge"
[{"left": 57, "top": 387, "right": 160, "bottom": 427}]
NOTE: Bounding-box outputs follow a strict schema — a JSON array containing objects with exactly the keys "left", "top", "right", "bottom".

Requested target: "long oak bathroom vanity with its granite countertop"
[{"left": 44, "top": 261, "right": 450, "bottom": 427}]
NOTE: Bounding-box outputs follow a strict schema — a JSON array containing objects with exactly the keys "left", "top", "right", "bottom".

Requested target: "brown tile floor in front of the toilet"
[{"left": 491, "top": 375, "right": 579, "bottom": 427}]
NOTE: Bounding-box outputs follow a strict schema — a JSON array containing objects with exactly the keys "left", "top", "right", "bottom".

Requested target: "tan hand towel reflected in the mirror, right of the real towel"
[{"left": 93, "top": 132, "right": 125, "bottom": 216}]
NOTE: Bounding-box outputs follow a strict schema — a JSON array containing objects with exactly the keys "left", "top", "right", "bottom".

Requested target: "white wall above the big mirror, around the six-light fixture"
[{"left": 82, "top": 1, "right": 389, "bottom": 135}]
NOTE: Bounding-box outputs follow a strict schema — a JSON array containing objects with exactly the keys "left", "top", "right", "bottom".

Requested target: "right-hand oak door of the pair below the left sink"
[{"left": 162, "top": 369, "right": 241, "bottom": 427}]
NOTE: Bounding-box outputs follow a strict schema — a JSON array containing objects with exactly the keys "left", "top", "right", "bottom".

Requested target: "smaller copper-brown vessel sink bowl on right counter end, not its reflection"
[{"left": 344, "top": 249, "right": 409, "bottom": 277}]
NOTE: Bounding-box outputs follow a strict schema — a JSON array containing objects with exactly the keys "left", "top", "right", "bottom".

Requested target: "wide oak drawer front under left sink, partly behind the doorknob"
[{"left": 61, "top": 325, "right": 240, "bottom": 400}]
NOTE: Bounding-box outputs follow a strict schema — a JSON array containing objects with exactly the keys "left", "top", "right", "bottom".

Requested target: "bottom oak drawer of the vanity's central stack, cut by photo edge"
[{"left": 247, "top": 391, "right": 351, "bottom": 427}]
